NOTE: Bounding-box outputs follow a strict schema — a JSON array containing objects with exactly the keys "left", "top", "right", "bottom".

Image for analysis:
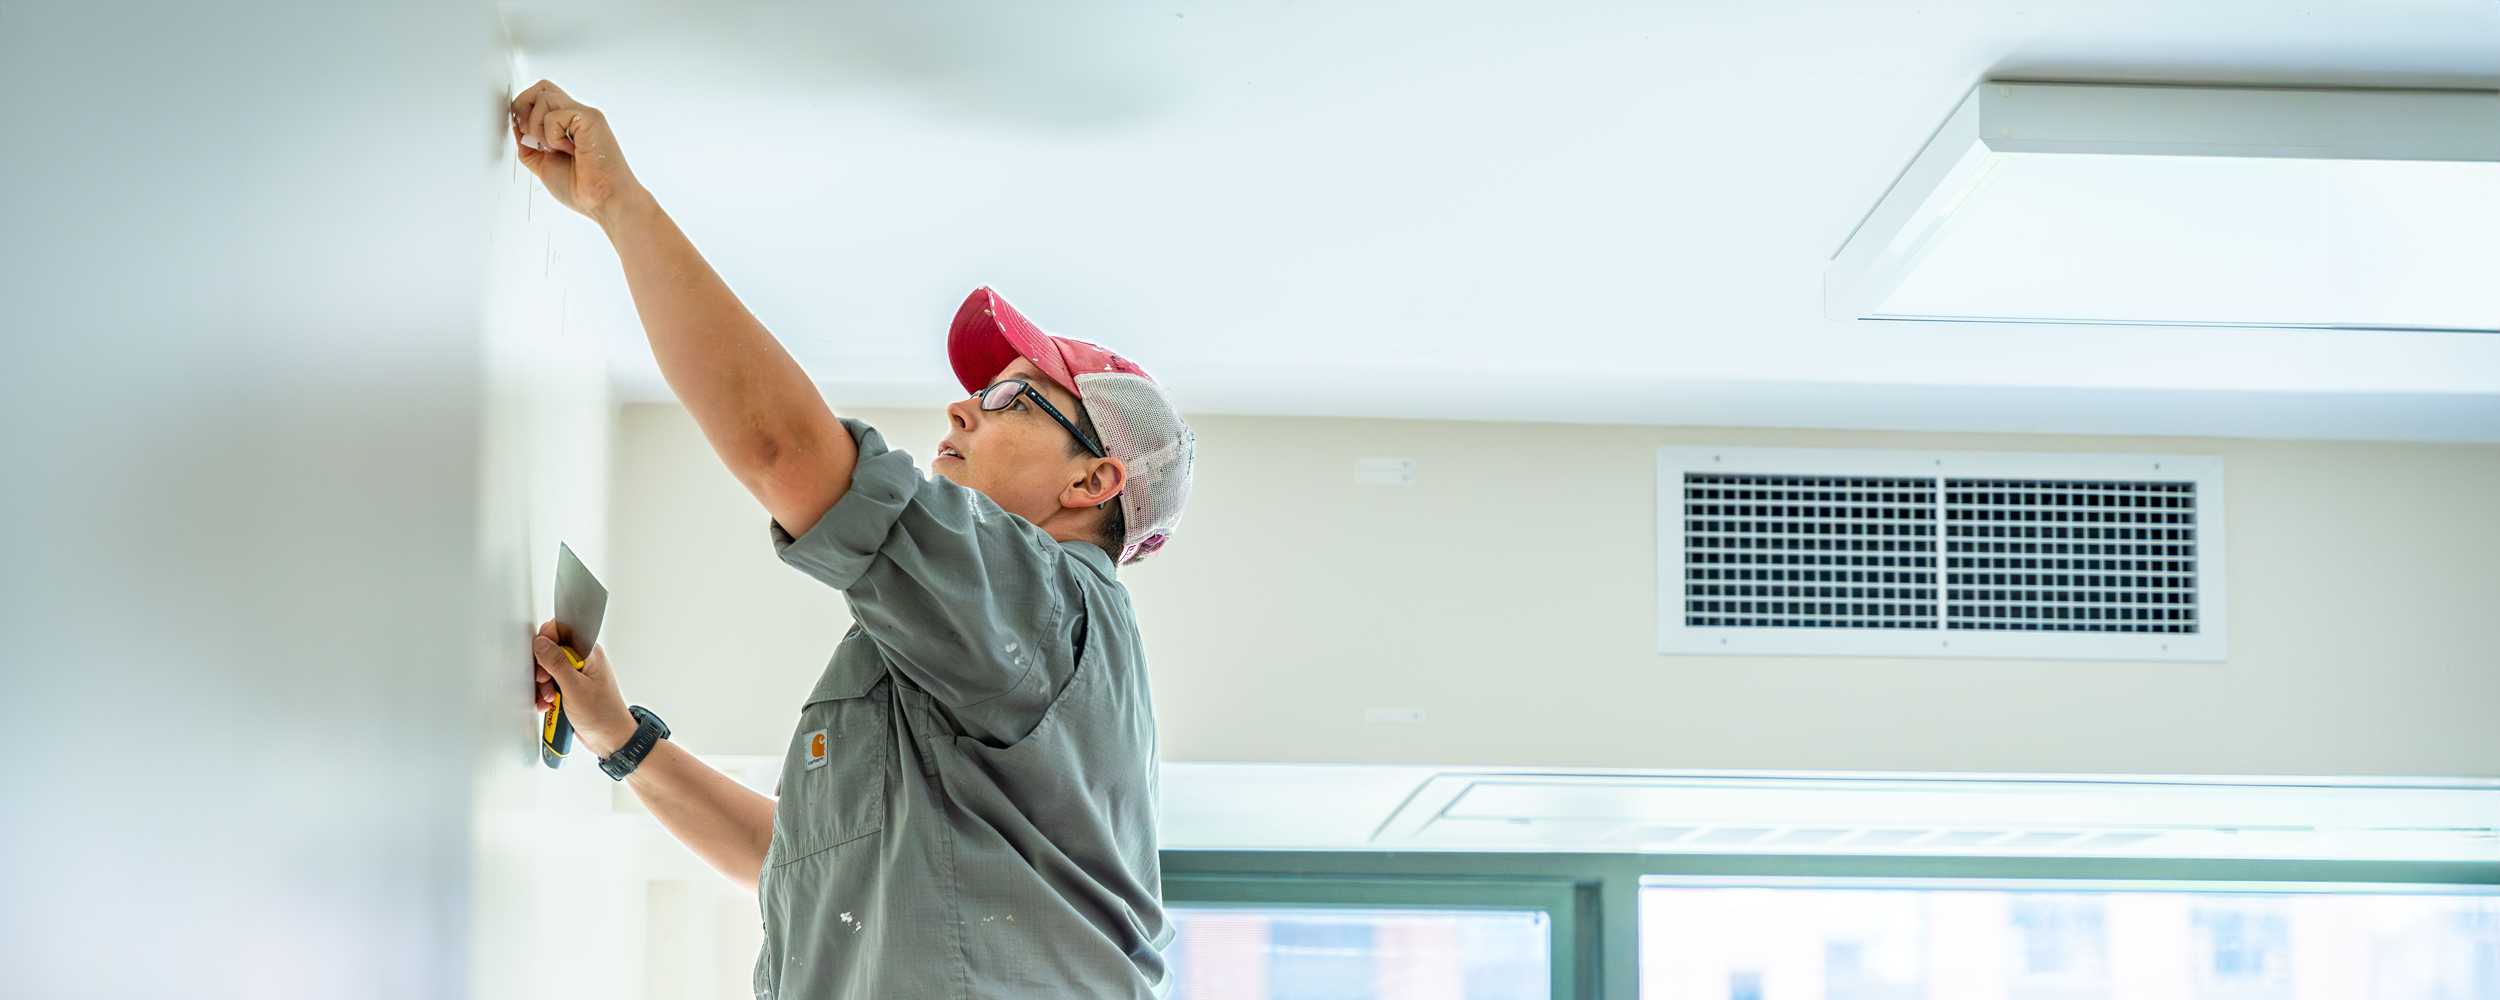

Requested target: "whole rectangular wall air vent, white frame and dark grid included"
[{"left": 1658, "top": 445, "right": 2228, "bottom": 660}]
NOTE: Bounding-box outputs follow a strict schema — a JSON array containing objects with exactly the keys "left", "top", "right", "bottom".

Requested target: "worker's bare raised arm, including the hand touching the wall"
[{"left": 513, "top": 80, "right": 858, "bottom": 535}]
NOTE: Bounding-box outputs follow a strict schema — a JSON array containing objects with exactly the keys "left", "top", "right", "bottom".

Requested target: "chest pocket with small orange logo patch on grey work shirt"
[{"left": 765, "top": 635, "right": 895, "bottom": 865}]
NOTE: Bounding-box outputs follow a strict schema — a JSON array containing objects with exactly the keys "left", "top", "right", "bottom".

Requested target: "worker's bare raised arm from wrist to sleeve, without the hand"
[{"left": 600, "top": 190, "right": 858, "bottom": 535}]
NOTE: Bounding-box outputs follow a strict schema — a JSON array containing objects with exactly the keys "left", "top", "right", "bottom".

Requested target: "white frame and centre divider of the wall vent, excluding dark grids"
[{"left": 1658, "top": 445, "right": 2230, "bottom": 663}]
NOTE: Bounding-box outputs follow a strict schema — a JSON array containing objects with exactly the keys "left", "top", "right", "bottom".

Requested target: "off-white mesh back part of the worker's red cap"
[{"left": 1078, "top": 373, "right": 1198, "bottom": 563}]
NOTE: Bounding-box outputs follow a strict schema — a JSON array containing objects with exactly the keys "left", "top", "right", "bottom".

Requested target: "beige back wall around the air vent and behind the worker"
[{"left": 613, "top": 405, "right": 2500, "bottom": 775}]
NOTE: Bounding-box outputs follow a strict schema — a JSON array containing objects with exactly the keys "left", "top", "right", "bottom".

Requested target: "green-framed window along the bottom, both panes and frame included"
[{"left": 1163, "top": 850, "right": 2500, "bottom": 1000}]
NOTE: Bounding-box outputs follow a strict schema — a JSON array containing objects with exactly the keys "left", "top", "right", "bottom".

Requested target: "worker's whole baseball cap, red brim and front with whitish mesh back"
[{"left": 945, "top": 288, "right": 1198, "bottom": 563}]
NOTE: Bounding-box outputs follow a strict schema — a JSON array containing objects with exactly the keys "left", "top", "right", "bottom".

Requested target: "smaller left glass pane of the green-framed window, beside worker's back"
[{"left": 1168, "top": 908, "right": 1553, "bottom": 1000}]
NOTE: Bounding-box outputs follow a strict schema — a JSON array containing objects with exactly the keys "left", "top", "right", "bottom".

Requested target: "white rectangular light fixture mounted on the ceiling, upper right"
[{"left": 1825, "top": 83, "right": 2500, "bottom": 333}]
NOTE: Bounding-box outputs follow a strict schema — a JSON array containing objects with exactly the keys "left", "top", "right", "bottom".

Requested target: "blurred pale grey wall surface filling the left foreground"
[{"left": 0, "top": 3, "right": 493, "bottom": 1000}]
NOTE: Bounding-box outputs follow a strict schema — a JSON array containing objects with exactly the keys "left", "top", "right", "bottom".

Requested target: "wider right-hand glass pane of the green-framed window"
[{"left": 1640, "top": 885, "right": 2500, "bottom": 1000}]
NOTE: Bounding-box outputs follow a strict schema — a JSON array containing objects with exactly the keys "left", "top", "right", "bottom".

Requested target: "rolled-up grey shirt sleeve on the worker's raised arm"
[{"left": 773, "top": 420, "right": 1073, "bottom": 725}]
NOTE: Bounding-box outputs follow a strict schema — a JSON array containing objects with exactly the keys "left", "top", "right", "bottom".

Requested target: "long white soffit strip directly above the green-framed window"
[{"left": 1160, "top": 760, "right": 2500, "bottom": 863}]
